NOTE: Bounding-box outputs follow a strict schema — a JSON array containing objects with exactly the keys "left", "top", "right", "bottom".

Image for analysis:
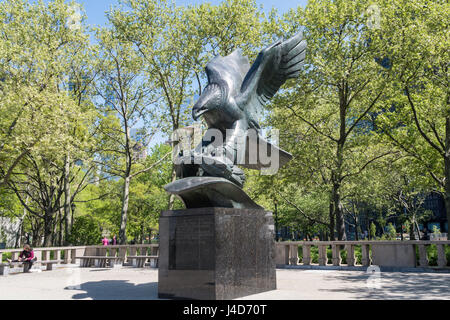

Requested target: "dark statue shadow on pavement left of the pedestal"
[{"left": 65, "top": 280, "right": 158, "bottom": 300}]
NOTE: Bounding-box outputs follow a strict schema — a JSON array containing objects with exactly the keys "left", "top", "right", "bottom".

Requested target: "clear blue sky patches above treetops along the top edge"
[{"left": 77, "top": 0, "right": 308, "bottom": 25}]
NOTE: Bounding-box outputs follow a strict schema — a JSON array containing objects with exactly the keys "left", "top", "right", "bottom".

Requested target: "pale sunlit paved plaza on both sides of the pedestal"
[{"left": 0, "top": 267, "right": 450, "bottom": 300}]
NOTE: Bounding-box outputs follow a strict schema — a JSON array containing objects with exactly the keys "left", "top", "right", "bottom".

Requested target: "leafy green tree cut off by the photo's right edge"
[{"left": 380, "top": 0, "right": 450, "bottom": 236}]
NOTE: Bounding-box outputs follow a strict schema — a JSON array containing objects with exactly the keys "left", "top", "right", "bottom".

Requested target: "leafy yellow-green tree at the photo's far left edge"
[{"left": 0, "top": 0, "right": 96, "bottom": 245}]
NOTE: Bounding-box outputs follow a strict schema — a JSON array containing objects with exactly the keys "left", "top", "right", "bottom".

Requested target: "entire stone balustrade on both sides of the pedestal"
[{"left": 0, "top": 240, "right": 450, "bottom": 269}]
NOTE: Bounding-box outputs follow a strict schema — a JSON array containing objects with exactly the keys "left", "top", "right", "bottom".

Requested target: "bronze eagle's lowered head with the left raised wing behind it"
[{"left": 192, "top": 50, "right": 250, "bottom": 120}]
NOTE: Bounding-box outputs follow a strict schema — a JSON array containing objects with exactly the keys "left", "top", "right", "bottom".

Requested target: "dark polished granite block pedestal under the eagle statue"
[{"left": 158, "top": 208, "right": 276, "bottom": 300}]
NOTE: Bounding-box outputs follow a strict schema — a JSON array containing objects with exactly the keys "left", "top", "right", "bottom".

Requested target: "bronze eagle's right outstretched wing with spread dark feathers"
[{"left": 236, "top": 32, "right": 306, "bottom": 129}]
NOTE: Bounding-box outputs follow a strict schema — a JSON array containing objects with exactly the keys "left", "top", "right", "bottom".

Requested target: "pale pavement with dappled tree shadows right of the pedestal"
[{"left": 237, "top": 270, "right": 450, "bottom": 300}]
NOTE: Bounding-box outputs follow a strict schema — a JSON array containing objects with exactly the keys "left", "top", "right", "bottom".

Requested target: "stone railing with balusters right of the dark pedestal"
[{"left": 275, "top": 241, "right": 450, "bottom": 269}]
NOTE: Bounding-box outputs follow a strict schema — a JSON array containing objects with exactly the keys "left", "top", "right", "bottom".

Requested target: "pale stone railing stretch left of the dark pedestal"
[{"left": 0, "top": 244, "right": 159, "bottom": 264}]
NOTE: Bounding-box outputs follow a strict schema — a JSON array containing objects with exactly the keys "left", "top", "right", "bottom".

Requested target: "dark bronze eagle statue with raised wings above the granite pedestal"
[{"left": 172, "top": 32, "right": 307, "bottom": 191}]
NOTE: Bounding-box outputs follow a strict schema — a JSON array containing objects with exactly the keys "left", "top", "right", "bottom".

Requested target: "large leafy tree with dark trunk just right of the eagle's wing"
[{"left": 271, "top": 0, "right": 391, "bottom": 240}]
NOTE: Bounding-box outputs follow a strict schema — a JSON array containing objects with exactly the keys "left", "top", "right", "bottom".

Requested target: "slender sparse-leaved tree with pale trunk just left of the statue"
[{"left": 96, "top": 29, "right": 171, "bottom": 244}]
